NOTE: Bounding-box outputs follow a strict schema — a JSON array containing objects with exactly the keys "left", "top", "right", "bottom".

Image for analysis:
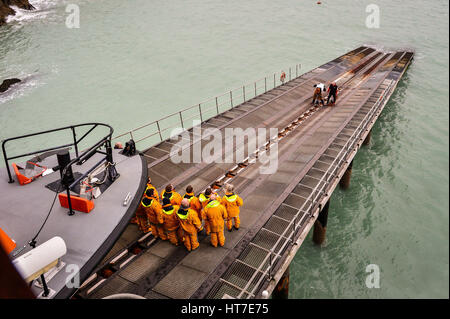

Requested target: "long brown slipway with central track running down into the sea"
[{"left": 74, "top": 46, "right": 414, "bottom": 298}]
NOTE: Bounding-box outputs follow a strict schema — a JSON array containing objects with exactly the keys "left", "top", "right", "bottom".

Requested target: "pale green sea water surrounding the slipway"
[{"left": 0, "top": 0, "right": 449, "bottom": 298}]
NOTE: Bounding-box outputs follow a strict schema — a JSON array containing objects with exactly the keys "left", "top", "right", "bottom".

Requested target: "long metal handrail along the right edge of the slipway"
[{"left": 243, "top": 81, "right": 394, "bottom": 298}]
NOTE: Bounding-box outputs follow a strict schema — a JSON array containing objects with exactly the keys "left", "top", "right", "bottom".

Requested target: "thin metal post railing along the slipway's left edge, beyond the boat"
[{"left": 112, "top": 64, "right": 301, "bottom": 146}]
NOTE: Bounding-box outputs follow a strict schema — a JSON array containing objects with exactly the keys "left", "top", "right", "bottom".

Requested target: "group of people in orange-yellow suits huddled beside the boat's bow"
[{"left": 135, "top": 178, "right": 243, "bottom": 251}]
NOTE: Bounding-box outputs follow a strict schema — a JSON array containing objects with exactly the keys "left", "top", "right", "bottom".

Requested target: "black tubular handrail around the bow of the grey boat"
[{"left": 2, "top": 123, "right": 114, "bottom": 183}]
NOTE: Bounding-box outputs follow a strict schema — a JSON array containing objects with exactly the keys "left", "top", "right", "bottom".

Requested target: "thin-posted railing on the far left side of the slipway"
[{"left": 113, "top": 64, "right": 301, "bottom": 151}]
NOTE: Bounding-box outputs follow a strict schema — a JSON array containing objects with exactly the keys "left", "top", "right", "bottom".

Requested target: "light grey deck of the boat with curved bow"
[{"left": 0, "top": 150, "right": 147, "bottom": 298}]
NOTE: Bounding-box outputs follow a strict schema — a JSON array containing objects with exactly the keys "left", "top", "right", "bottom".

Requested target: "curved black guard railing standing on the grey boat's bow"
[{"left": 2, "top": 123, "right": 114, "bottom": 183}]
